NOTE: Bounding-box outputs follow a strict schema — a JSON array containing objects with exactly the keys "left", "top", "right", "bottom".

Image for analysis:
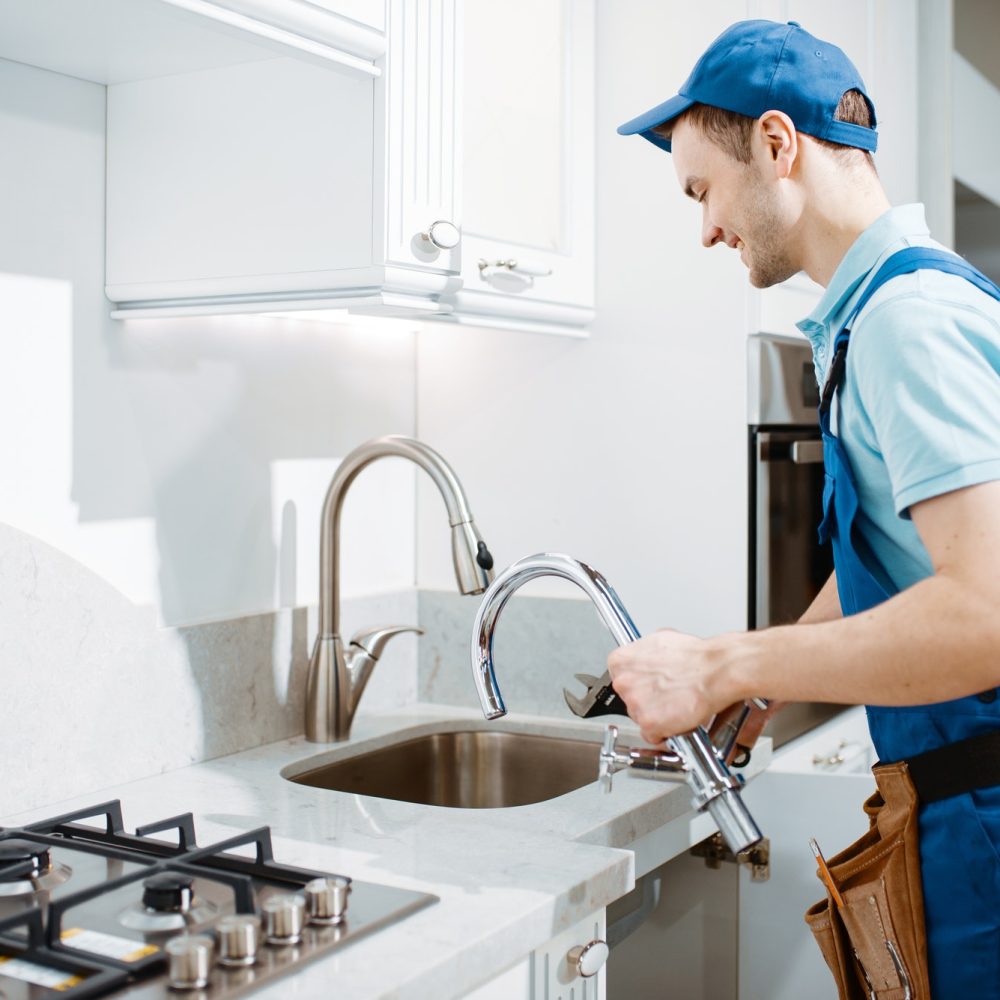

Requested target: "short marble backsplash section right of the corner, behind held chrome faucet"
[{"left": 417, "top": 590, "right": 614, "bottom": 716}]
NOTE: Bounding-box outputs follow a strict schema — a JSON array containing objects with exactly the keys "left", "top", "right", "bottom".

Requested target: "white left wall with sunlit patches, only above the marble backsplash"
[{"left": 0, "top": 61, "right": 415, "bottom": 624}]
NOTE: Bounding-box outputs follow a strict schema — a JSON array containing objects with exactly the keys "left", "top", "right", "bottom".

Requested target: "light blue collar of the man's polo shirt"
[{"left": 795, "top": 204, "right": 930, "bottom": 368}]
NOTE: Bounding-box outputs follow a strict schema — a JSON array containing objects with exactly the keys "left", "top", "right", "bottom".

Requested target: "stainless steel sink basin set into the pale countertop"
[{"left": 282, "top": 730, "right": 600, "bottom": 809}]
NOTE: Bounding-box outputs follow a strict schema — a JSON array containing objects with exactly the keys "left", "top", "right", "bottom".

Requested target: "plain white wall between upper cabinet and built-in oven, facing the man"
[{"left": 417, "top": 0, "right": 746, "bottom": 633}]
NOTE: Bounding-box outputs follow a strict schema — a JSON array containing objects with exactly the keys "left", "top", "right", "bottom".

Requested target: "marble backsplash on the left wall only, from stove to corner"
[{"left": 0, "top": 525, "right": 417, "bottom": 816}]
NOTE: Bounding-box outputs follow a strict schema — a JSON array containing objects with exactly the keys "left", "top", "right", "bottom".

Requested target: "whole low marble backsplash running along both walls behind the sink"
[{"left": 0, "top": 525, "right": 612, "bottom": 815}]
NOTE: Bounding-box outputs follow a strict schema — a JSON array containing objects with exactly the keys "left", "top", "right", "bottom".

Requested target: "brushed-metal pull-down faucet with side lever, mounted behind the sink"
[{"left": 306, "top": 435, "right": 493, "bottom": 743}]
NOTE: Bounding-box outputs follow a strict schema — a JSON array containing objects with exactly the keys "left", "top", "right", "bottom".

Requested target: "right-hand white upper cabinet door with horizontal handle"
[{"left": 450, "top": 0, "right": 595, "bottom": 332}]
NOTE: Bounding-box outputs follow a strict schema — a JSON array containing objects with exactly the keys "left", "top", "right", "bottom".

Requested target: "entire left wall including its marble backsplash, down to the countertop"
[{"left": 0, "top": 54, "right": 426, "bottom": 815}]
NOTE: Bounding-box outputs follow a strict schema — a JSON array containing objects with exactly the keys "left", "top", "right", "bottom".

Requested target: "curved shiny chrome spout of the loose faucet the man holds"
[{"left": 472, "top": 552, "right": 639, "bottom": 719}]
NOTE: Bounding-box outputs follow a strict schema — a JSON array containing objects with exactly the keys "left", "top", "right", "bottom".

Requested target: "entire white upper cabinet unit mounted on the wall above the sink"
[{"left": 0, "top": 0, "right": 595, "bottom": 333}]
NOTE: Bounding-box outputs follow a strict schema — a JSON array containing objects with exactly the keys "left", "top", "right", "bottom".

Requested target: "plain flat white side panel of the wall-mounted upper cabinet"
[{"left": 107, "top": 59, "right": 373, "bottom": 301}]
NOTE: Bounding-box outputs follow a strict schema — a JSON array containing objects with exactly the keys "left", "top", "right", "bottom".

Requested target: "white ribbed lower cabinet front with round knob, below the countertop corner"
[{"left": 463, "top": 910, "right": 608, "bottom": 1000}]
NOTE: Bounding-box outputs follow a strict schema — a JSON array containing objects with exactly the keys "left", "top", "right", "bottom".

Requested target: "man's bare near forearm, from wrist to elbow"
[{"left": 724, "top": 574, "right": 1000, "bottom": 705}]
